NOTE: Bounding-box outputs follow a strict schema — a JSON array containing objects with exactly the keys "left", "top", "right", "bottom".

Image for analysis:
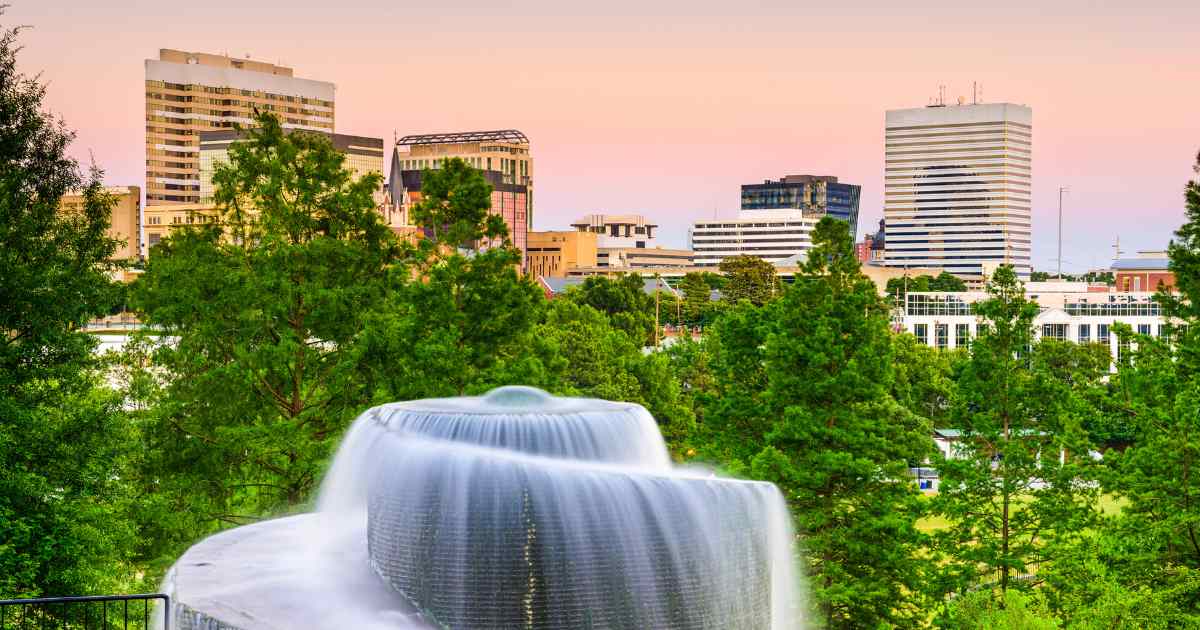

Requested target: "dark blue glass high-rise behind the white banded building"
[{"left": 742, "top": 175, "right": 862, "bottom": 235}]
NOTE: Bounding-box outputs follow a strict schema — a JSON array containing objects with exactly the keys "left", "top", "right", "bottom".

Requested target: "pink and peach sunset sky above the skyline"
[{"left": 9, "top": 0, "right": 1200, "bottom": 270}]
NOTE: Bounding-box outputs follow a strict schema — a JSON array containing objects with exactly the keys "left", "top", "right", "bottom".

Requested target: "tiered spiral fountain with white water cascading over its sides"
[{"left": 157, "top": 386, "right": 802, "bottom": 630}]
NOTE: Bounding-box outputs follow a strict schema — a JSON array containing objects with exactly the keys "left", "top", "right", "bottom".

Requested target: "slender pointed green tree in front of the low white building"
[{"left": 932, "top": 265, "right": 1098, "bottom": 600}]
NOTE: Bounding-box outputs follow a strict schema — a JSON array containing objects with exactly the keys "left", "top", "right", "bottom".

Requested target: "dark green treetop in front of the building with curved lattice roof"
[{"left": 412, "top": 157, "right": 508, "bottom": 247}]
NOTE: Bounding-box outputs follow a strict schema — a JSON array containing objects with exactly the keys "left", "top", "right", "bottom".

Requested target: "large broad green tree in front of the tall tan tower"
[{"left": 133, "top": 114, "right": 397, "bottom": 541}]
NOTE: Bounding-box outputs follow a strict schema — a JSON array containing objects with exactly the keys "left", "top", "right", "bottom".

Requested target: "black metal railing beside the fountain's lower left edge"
[{"left": 0, "top": 593, "right": 170, "bottom": 630}]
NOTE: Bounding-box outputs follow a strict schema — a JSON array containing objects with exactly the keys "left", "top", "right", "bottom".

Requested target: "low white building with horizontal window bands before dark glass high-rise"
[{"left": 688, "top": 210, "right": 821, "bottom": 266}]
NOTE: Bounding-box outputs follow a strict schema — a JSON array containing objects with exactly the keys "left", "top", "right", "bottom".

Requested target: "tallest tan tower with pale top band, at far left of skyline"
[{"left": 145, "top": 49, "right": 334, "bottom": 205}]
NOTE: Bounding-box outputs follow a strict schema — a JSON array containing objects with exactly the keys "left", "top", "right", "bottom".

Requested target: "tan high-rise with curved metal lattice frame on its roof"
[{"left": 388, "top": 130, "right": 533, "bottom": 252}]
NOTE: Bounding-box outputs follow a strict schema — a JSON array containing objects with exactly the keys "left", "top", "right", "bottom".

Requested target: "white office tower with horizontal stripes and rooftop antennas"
[{"left": 883, "top": 103, "right": 1033, "bottom": 280}]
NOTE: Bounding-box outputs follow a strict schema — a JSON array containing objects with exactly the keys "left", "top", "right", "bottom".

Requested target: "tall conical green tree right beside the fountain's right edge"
[{"left": 739, "top": 217, "right": 932, "bottom": 628}]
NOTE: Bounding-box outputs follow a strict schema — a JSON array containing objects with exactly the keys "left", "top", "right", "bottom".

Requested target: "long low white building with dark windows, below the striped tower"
[{"left": 898, "top": 281, "right": 1166, "bottom": 358}]
